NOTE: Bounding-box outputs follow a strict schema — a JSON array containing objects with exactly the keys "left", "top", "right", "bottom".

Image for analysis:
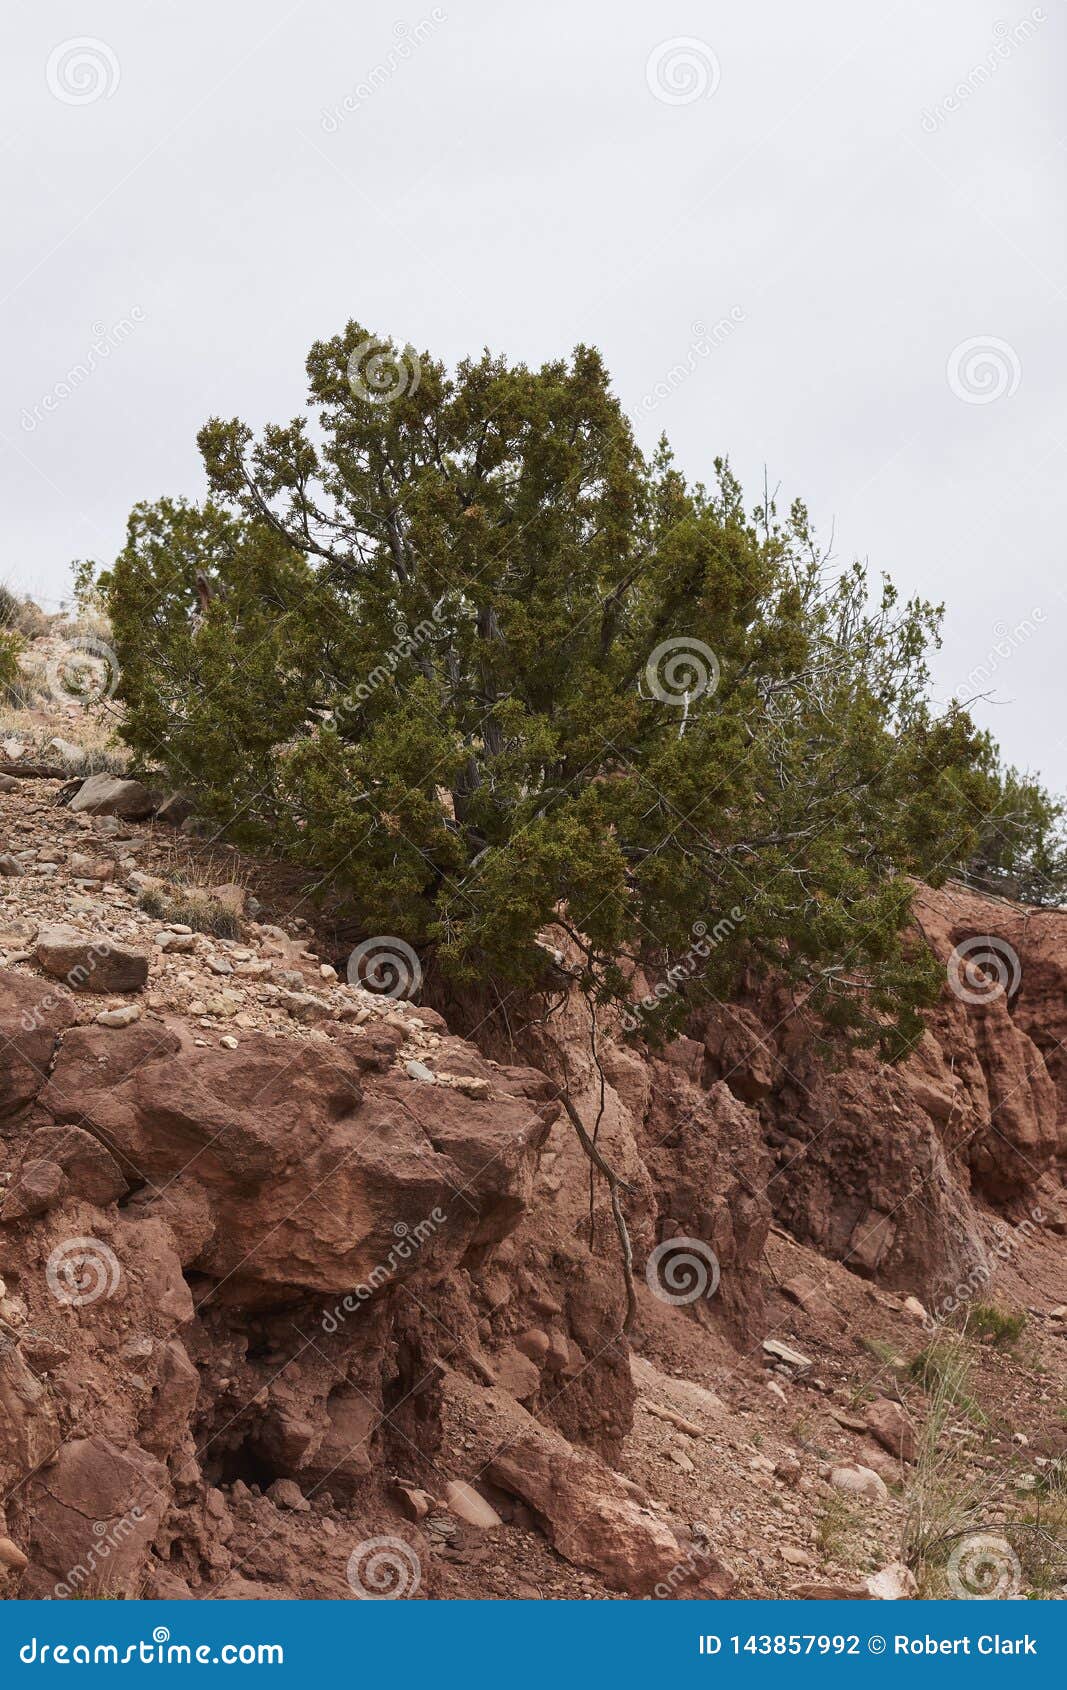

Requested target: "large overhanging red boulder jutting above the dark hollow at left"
[{"left": 42, "top": 1024, "right": 555, "bottom": 1323}]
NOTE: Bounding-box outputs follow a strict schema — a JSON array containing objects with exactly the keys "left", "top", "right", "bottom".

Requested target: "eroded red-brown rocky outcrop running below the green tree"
[{"left": 0, "top": 892, "right": 1067, "bottom": 1597}]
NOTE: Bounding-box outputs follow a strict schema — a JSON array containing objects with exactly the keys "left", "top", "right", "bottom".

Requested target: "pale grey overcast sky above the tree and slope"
[{"left": 0, "top": 0, "right": 1067, "bottom": 789}]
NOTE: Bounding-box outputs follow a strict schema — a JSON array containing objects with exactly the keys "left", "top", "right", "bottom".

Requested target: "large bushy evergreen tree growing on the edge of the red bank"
[{"left": 98, "top": 323, "right": 1061, "bottom": 1055}]
